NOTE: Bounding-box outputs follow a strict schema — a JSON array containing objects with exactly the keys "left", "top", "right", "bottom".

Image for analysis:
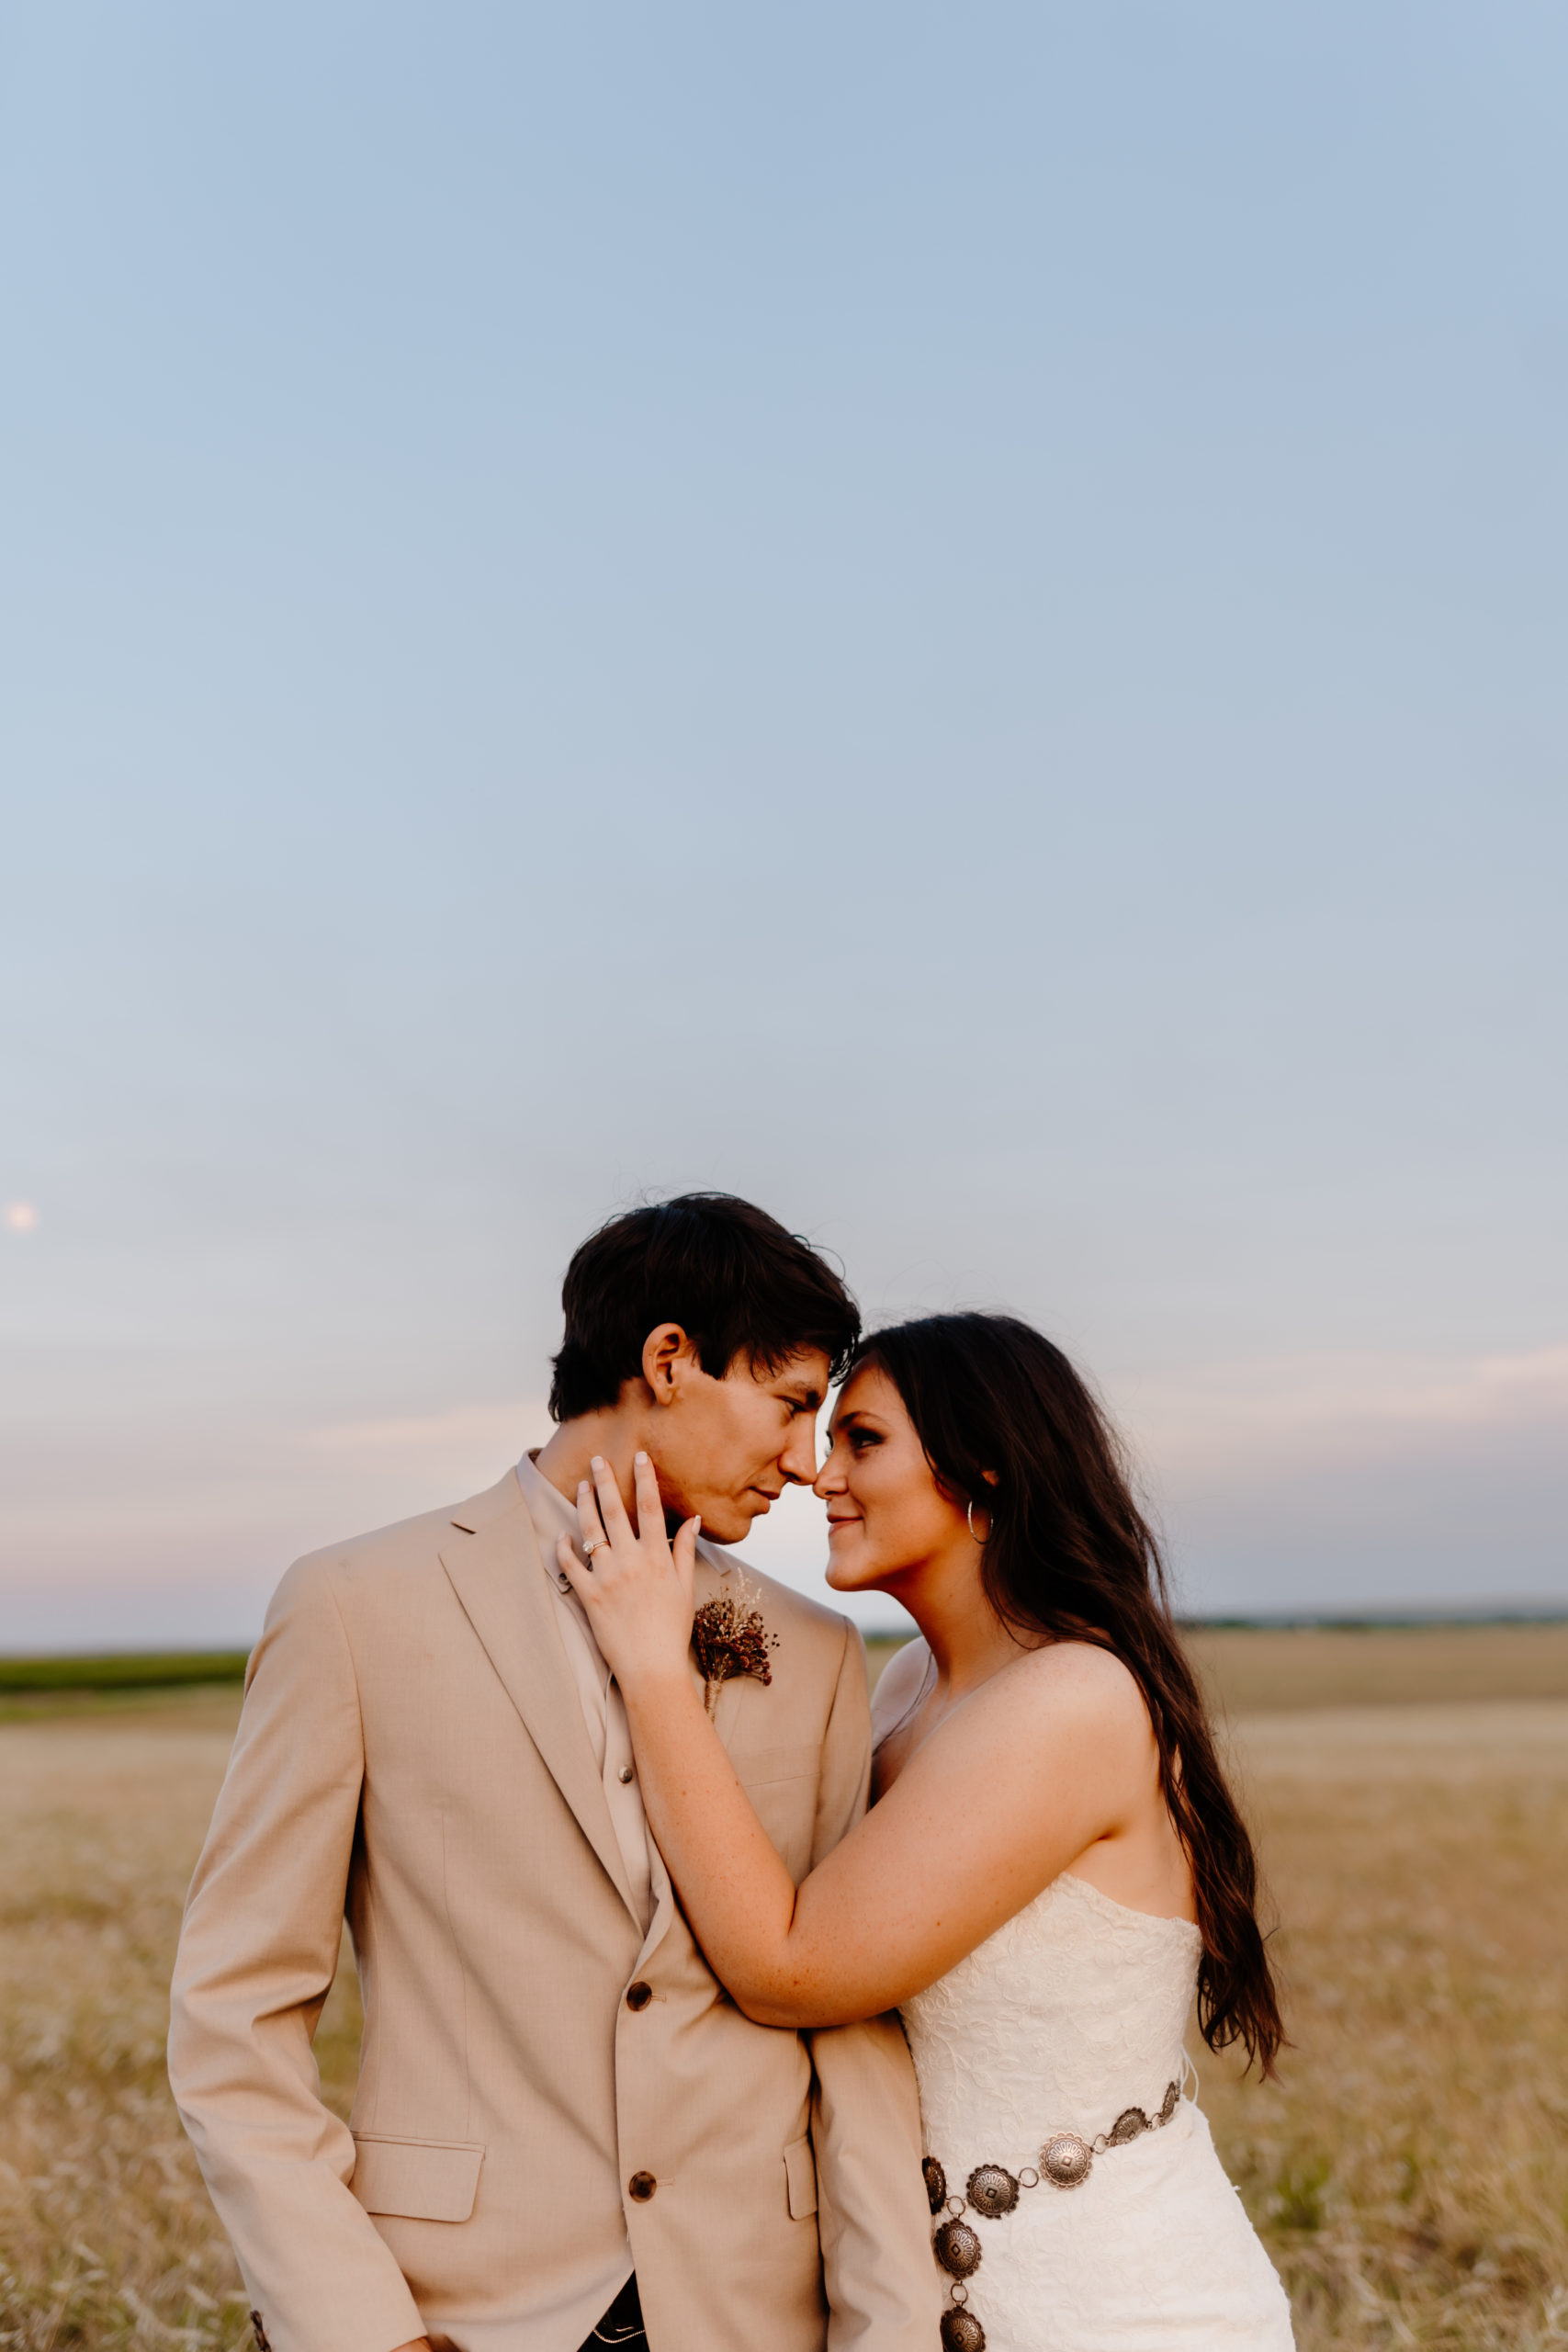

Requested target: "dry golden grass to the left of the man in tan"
[{"left": 0, "top": 1691, "right": 360, "bottom": 2352}]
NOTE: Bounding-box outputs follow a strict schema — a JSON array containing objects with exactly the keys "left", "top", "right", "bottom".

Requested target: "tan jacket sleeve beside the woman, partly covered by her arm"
[{"left": 808, "top": 1625, "right": 941, "bottom": 2352}]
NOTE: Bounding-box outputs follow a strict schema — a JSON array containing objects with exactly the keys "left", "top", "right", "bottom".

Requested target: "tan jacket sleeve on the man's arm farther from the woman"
[{"left": 169, "top": 1559, "right": 423, "bottom": 2352}]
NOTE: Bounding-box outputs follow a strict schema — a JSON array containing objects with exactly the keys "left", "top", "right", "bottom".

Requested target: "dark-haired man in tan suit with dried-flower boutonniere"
[{"left": 169, "top": 1194, "right": 938, "bottom": 2352}]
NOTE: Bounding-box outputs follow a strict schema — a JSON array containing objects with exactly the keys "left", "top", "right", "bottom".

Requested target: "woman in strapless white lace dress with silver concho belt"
[{"left": 559, "top": 1315, "right": 1291, "bottom": 2352}]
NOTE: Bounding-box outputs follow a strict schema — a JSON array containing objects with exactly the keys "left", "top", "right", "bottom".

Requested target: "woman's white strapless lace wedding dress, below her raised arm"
[{"left": 903, "top": 1874, "right": 1293, "bottom": 2352}]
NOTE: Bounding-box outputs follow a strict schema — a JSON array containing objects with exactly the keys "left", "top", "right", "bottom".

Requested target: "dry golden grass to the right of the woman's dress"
[{"left": 1201, "top": 1701, "right": 1568, "bottom": 2352}]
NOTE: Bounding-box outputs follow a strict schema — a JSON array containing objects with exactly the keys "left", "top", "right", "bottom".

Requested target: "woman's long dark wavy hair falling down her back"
[{"left": 851, "top": 1315, "right": 1286, "bottom": 2075}]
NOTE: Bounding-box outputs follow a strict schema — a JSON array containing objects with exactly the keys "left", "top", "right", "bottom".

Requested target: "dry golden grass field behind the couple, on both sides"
[{"left": 0, "top": 1628, "right": 1568, "bottom": 2352}]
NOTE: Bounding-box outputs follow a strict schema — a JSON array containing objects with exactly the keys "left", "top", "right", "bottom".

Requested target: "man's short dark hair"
[{"left": 550, "top": 1193, "right": 861, "bottom": 1420}]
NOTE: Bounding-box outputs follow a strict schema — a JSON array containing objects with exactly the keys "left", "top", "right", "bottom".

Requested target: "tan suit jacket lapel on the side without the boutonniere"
[{"left": 442, "top": 1494, "right": 637, "bottom": 1917}]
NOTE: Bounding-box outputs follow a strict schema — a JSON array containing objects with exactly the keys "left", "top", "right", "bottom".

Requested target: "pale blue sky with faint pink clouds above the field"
[{"left": 0, "top": 0, "right": 1568, "bottom": 1646}]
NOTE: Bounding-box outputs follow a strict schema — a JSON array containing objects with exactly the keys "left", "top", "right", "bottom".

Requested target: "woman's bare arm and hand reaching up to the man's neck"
[{"left": 559, "top": 1461, "right": 1155, "bottom": 2025}]
